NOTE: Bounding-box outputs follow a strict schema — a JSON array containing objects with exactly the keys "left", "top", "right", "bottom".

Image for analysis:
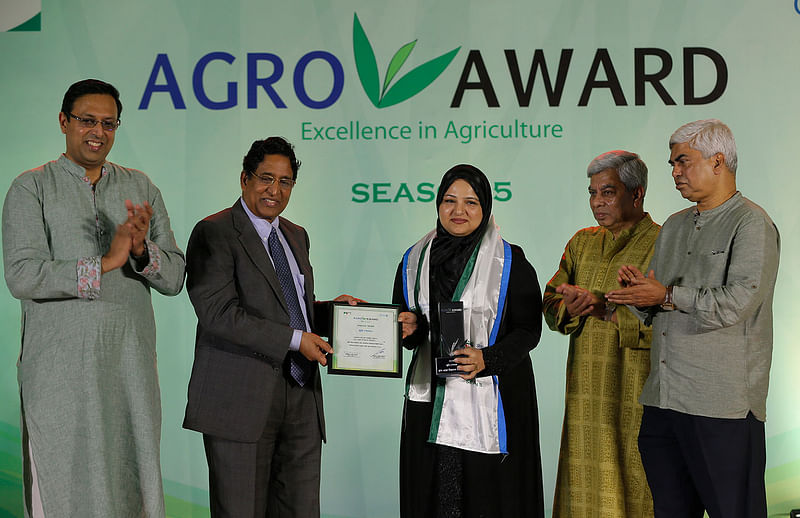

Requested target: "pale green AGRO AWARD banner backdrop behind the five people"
[{"left": 0, "top": 0, "right": 800, "bottom": 518}]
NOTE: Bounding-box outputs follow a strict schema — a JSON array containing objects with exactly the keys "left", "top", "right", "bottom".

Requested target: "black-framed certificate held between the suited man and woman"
[{"left": 328, "top": 302, "right": 403, "bottom": 378}]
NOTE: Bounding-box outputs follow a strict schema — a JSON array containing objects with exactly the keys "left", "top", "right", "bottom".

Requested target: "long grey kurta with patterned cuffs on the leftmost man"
[{"left": 3, "top": 155, "right": 185, "bottom": 518}]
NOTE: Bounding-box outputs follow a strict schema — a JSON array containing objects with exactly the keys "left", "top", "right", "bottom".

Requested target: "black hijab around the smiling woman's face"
[{"left": 430, "top": 164, "right": 492, "bottom": 302}]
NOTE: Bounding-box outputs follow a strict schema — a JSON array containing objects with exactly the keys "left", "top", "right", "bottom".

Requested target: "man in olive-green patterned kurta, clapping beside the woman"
[{"left": 544, "top": 151, "right": 660, "bottom": 518}]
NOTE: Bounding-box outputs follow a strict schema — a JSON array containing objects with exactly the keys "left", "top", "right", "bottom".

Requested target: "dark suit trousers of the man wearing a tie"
[{"left": 203, "top": 381, "right": 322, "bottom": 518}]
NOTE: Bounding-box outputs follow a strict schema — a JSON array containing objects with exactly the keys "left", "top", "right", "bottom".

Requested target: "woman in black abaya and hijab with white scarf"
[{"left": 393, "top": 164, "right": 544, "bottom": 518}]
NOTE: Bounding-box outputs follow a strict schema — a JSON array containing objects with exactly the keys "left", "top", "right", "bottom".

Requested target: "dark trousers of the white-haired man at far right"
[{"left": 639, "top": 406, "right": 767, "bottom": 518}]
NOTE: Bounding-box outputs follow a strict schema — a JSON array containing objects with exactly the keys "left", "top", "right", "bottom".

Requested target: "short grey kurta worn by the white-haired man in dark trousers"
[{"left": 639, "top": 192, "right": 780, "bottom": 421}]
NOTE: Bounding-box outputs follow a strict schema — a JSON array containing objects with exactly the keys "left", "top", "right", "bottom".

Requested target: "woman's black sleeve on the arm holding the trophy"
[{"left": 479, "top": 245, "right": 542, "bottom": 376}]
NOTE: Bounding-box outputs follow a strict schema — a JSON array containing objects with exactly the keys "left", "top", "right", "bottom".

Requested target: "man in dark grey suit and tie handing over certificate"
[{"left": 183, "top": 137, "right": 358, "bottom": 518}]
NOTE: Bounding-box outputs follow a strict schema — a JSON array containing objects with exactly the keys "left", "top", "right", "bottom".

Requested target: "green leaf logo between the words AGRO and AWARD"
[{"left": 353, "top": 14, "right": 461, "bottom": 108}]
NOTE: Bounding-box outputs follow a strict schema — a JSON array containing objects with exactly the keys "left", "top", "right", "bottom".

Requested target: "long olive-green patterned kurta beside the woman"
[{"left": 544, "top": 214, "right": 660, "bottom": 518}]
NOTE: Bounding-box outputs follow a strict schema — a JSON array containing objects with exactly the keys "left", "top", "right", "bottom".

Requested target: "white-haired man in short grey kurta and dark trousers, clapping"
[{"left": 607, "top": 119, "right": 780, "bottom": 518}]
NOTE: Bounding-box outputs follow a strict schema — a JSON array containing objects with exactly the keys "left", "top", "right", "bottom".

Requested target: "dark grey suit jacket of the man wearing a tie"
[{"left": 183, "top": 200, "right": 325, "bottom": 442}]
